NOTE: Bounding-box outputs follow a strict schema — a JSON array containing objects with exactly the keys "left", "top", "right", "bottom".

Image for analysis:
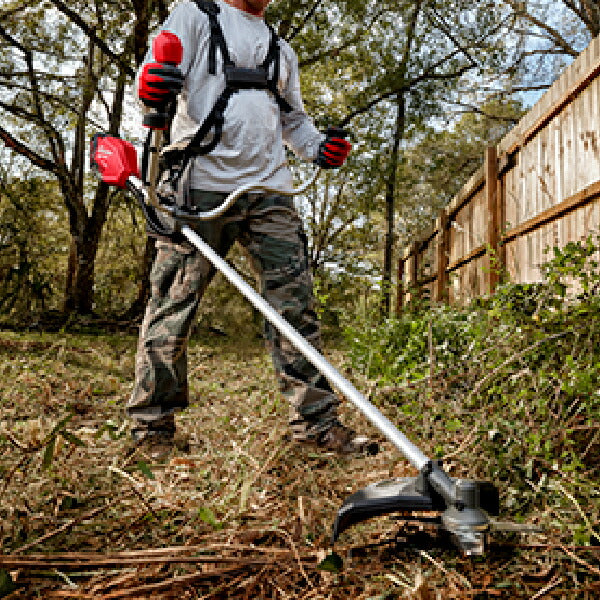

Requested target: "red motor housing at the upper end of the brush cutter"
[{"left": 90, "top": 133, "right": 140, "bottom": 188}]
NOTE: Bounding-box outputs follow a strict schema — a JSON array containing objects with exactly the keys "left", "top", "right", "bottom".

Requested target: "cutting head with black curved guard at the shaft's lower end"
[{"left": 332, "top": 462, "right": 500, "bottom": 555}]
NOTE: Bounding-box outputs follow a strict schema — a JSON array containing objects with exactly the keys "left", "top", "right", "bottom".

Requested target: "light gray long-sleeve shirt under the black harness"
[{"left": 144, "top": 0, "right": 323, "bottom": 192}]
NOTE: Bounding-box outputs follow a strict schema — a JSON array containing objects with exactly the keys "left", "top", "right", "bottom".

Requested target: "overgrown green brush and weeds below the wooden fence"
[{"left": 346, "top": 239, "right": 600, "bottom": 545}]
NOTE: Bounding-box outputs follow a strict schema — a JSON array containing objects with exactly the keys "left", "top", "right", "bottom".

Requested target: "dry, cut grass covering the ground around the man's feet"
[{"left": 0, "top": 333, "right": 600, "bottom": 599}]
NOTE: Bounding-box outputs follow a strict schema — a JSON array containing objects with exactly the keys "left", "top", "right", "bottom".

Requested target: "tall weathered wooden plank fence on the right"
[{"left": 398, "top": 38, "right": 600, "bottom": 310}]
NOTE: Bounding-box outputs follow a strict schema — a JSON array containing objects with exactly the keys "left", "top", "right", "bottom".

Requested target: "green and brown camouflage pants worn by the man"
[{"left": 127, "top": 190, "right": 338, "bottom": 439}]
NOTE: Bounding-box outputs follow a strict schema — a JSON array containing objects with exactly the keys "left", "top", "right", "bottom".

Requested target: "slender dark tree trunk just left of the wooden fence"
[{"left": 381, "top": 94, "right": 405, "bottom": 316}]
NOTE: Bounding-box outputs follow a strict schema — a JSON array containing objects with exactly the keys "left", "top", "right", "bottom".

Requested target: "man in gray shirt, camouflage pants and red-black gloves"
[{"left": 127, "top": 0, "right": 376, "bottom": 453}]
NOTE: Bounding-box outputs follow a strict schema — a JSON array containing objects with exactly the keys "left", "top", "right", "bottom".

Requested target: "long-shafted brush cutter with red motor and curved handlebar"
[{"left": 90, "top": 30, "right": 506, "bottom": 555}]
